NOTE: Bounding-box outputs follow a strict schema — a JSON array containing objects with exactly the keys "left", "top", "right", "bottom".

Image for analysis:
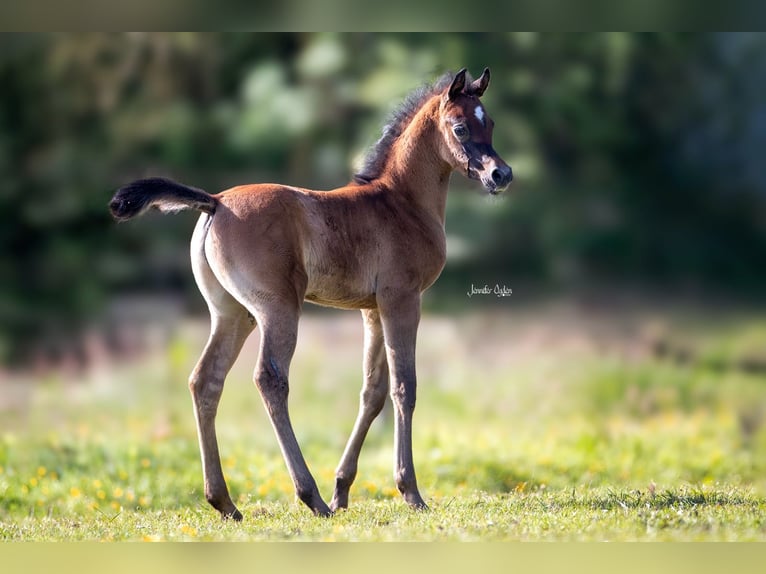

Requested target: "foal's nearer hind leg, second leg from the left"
[{"left": 255, "top": 304, "right": 332, "bottom": 516}]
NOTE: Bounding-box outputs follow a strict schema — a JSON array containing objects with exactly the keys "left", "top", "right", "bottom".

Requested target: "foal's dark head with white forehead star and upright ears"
[{"left": 439, "top": 68, "right": 513, "bottom": 195}]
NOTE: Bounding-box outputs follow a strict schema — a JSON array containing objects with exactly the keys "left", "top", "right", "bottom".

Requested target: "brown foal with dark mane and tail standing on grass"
[{"left": 109, "top": 69, "right": 512, "bottom": 520}]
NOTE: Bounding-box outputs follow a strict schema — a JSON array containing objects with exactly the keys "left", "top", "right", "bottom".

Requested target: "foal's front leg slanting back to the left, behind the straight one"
[{"left": 330, "top": 309, "right": 388, "bottom": 510}]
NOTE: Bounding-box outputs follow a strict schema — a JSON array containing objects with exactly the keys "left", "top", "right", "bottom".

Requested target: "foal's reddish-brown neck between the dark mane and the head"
[{"left": 386, "top": 98, "right": 452, "bottom": 227}]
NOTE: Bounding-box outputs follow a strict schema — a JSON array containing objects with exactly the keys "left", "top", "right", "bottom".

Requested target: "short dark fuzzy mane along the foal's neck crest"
[{"left": 354, "top": 72, "right": 462, "bottom": 185}]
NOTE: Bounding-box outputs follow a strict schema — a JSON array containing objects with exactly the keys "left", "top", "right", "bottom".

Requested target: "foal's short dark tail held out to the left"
[{"left": 109, "top": 177, "right": 218, "bottom": 221}]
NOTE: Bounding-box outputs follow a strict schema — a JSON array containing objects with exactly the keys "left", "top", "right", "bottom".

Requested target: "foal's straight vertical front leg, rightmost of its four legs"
[{"left": 378, "top": 294, "right": 428, "bottom": 509}]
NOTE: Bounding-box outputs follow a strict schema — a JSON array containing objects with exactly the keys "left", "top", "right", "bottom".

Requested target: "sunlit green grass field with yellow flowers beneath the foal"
[{"left": 0, "top": 302, "right": 766, "bottom": 541}]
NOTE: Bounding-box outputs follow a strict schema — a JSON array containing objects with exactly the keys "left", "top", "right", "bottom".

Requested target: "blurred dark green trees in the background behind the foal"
[{"left": 0, "top": 33, "right": 766, "bottom": 365}]
